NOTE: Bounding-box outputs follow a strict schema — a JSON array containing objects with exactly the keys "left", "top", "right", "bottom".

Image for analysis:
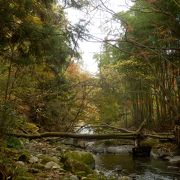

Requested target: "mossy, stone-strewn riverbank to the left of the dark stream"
[{"left": 0, "top": 138, "right": 112, "bottom": 180}]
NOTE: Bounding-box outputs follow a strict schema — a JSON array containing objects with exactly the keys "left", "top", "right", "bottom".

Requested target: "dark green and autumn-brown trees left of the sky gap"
[{"left": 0, "top": 0, "right": 87, "bottom": 134}]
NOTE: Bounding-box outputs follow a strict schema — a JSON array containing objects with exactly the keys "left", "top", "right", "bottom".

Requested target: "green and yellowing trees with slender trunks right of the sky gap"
[{"left": 95, "top": 0, "right": 180, "bottom": 128}]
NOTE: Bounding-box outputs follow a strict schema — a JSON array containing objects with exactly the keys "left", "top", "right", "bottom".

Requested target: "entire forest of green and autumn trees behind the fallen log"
[{"left": 0, "top": 0, "right": 180, "bottom": 179}]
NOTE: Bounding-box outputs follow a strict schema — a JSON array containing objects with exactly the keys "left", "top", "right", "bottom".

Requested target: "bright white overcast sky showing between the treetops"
[{"left": 66, "top": 0, "right": 130, "bottom": 74}]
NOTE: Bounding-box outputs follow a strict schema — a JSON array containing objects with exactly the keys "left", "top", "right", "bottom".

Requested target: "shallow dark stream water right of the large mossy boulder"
[{"left": 96, "top": 154, "right": 180, "bottom": 180}]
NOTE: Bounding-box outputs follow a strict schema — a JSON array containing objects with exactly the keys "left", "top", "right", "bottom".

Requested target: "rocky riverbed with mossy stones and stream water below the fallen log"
[{"left": 0, "top": 138, "right": 180, "bottom": 180}]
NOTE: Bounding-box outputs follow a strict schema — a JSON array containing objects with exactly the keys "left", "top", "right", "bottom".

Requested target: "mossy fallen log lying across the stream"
[{"left": 8, "top": 120, "right": 175, "bottom": 143}]
